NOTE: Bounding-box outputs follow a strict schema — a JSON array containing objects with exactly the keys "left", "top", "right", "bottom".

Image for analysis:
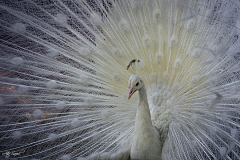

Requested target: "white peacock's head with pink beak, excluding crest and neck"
[{"left": 128, "top": 74, "right": 143, "bottom": 99}]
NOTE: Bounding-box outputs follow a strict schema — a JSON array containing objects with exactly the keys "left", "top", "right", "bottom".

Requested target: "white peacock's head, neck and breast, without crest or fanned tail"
[{"left": 128, "top": 75, "right": 162, "bottom": 160}]
